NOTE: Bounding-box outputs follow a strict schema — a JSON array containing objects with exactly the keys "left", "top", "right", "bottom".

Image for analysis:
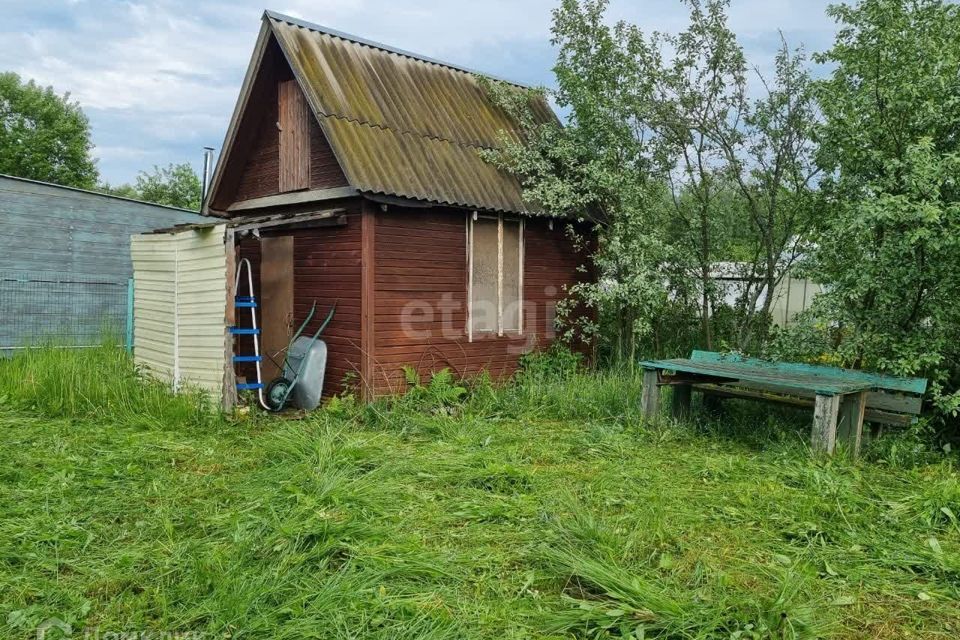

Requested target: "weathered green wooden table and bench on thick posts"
[{"left": 640, "top": 351, "right": 927, "bottom": 455}]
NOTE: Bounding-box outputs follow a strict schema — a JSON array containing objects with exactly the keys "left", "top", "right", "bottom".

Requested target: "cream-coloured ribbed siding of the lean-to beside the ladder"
[{"left": 130, "top": 225, "right": 232, "bottom": 401}]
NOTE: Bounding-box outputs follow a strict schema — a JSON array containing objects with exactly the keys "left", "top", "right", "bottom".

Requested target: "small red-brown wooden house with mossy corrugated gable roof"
[{"left": 131, "top": 12, "right": 584, "bottom": 404}]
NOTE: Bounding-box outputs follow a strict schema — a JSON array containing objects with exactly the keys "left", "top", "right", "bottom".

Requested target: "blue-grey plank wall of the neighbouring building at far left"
[{"left": 0, "top": 175, "right": 206, "bottom": 352}]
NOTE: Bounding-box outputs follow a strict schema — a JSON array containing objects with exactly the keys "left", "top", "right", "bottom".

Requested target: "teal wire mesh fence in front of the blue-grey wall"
[{"left": 0, "top": 271, "right": 133, "bottom": 355}]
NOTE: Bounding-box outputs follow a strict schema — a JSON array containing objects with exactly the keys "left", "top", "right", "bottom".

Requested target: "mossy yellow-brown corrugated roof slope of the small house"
[{"left": 264, "top": 12, "right": 556, "bottom": 212}]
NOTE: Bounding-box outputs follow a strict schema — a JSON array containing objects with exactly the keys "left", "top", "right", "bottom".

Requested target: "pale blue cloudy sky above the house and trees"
[{"left": 0, "top": 0, "right": 834, "bottom": 184}]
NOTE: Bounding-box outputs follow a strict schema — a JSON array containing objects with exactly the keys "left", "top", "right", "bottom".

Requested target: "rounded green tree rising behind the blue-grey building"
[{"left": 0, "top": 73, "right": 97, "bottom": 189}]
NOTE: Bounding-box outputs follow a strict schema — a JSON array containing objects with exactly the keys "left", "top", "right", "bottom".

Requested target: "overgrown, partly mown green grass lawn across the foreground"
[{"left": 0, "top": 348, "right": 960, "bottom": 640}]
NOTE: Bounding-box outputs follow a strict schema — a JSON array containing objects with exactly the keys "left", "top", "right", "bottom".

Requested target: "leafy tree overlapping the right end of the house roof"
[{"left": 486, "top": 0, "right": 669, "bottom": 361}]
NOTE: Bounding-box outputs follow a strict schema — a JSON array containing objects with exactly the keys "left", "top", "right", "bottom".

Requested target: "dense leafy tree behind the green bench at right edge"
[{"left": 800, "top": 0, "right": 960, "bottom": 414}]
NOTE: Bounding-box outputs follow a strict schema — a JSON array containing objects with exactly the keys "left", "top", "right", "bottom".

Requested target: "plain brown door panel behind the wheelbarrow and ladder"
[{"left": 260, "top": 236, "right": 293, "bottom": 383}]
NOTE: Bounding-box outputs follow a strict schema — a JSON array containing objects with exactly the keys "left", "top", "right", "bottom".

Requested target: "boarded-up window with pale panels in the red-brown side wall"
[{"left": 470, "top": 216, "right": 523, "bottom": 336}]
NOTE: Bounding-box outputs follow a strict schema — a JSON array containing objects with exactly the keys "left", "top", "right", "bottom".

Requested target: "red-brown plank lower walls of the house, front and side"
[{"left": 236, "top": 199, "right": 583, "bottom": 397}]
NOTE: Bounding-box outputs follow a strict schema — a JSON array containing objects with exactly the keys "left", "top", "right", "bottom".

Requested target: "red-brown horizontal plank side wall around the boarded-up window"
[{"left": 374, "top": 209, "right": 582, "bottom": 394}]
